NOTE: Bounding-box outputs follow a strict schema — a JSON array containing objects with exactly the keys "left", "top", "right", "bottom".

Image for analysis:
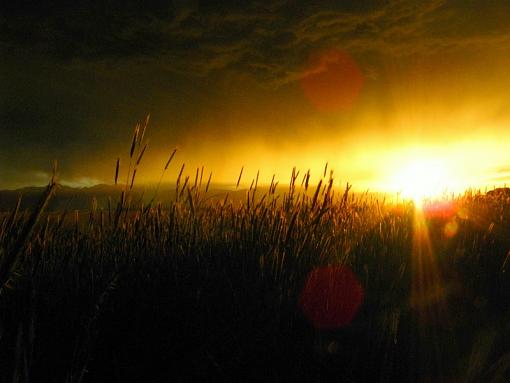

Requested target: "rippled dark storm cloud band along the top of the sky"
[{"left": 0, "top": 0, "right": 510, "bottom": 84}]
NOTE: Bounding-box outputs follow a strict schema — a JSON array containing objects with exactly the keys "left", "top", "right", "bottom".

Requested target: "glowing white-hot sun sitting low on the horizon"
[{"left": 391, "top": 158, "right": 452, "bottom": 205}]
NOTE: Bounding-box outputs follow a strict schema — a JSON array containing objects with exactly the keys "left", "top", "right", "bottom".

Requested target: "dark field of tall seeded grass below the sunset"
[{"left": 0, "top": 172, "right": 510, "bottom": 382}]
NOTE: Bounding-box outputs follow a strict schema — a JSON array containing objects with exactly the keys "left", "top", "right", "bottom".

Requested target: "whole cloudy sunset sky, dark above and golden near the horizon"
[{"left": 0, "top": 0, "right": 510, "bottom": 190}]
